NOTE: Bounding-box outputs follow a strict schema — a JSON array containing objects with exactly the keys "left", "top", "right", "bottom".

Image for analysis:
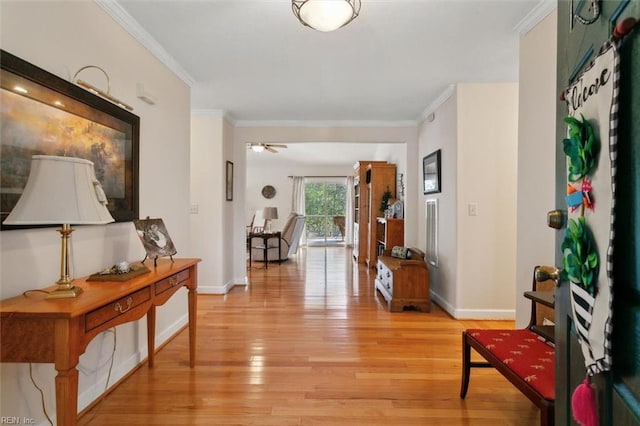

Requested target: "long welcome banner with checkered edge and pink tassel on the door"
[{"left": 561, "top": 35, "right": 620, "bottom": 425}]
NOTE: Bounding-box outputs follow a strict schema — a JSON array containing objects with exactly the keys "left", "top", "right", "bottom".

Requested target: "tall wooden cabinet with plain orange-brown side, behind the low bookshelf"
[{"left": 360, "top": 163, "right": 396, "bottom": 268}]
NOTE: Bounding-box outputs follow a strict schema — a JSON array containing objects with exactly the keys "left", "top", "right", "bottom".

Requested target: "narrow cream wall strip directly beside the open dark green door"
[{"left": 515, "top": 11, "right": 558, "bottom": 327}]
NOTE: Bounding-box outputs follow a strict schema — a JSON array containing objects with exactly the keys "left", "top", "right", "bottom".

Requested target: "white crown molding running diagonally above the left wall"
[{"left": 94, "top": 0, "right": 195, "bottom": 87}]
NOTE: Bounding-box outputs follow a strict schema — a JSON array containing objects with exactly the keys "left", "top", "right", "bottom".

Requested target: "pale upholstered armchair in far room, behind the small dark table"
[{"left": 250, "top": 212, "right": 305, "bottom": 262}]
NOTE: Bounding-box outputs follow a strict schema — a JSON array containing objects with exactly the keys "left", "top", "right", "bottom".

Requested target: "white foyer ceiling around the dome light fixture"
[{"left": 105, "top": 0, "right": 555, "bottom": 125}]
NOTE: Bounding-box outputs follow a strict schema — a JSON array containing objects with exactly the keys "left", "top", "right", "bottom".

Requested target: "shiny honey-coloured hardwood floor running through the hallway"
[{"left": 79, "top": 247, "right": 539, "bottom": 426}]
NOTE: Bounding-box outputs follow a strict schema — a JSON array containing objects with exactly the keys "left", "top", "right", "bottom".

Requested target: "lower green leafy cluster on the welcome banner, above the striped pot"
[{"left": 561, "top": 216, "right": 599, "bottom": 296}]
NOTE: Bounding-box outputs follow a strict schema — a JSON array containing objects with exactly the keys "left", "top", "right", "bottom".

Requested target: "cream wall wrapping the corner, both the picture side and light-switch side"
[{"left": 416, "top": 83, "right": 518, "bottom": 318}]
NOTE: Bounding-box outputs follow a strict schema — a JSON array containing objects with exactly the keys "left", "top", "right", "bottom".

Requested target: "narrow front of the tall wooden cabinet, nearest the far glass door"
[{"left": 353, "top": 161, "right": 386, "bottom": 263}]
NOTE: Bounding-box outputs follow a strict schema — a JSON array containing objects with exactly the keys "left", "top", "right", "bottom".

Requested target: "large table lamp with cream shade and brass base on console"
[{"left": 3, "top": 155, "right": 114, "bottom": 299}]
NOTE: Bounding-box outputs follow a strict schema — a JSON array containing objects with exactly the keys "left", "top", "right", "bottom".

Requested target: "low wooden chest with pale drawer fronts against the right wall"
[{"left": 375, "top": 248, "right": 431, "bottom": 312}]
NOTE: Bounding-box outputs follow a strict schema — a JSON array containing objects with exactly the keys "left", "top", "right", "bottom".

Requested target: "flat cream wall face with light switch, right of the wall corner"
[{"left": 456, "top": 83, "right": 518, "bottom": 318}]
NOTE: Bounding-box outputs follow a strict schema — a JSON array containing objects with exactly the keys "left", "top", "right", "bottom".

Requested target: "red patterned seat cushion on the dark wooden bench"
[{"left": 467, "top": 329, "right": 556, "bottom": 400}]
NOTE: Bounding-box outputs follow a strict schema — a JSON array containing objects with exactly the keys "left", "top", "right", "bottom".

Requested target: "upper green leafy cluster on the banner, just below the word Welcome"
[{"left": 562, "top": 114, "right": 600, "bottom": 182}]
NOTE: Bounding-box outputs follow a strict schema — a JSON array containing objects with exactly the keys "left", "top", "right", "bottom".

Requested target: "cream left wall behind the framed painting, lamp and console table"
[{"left": 0, "top": 1, "right": 190, "bottom": 424}]
